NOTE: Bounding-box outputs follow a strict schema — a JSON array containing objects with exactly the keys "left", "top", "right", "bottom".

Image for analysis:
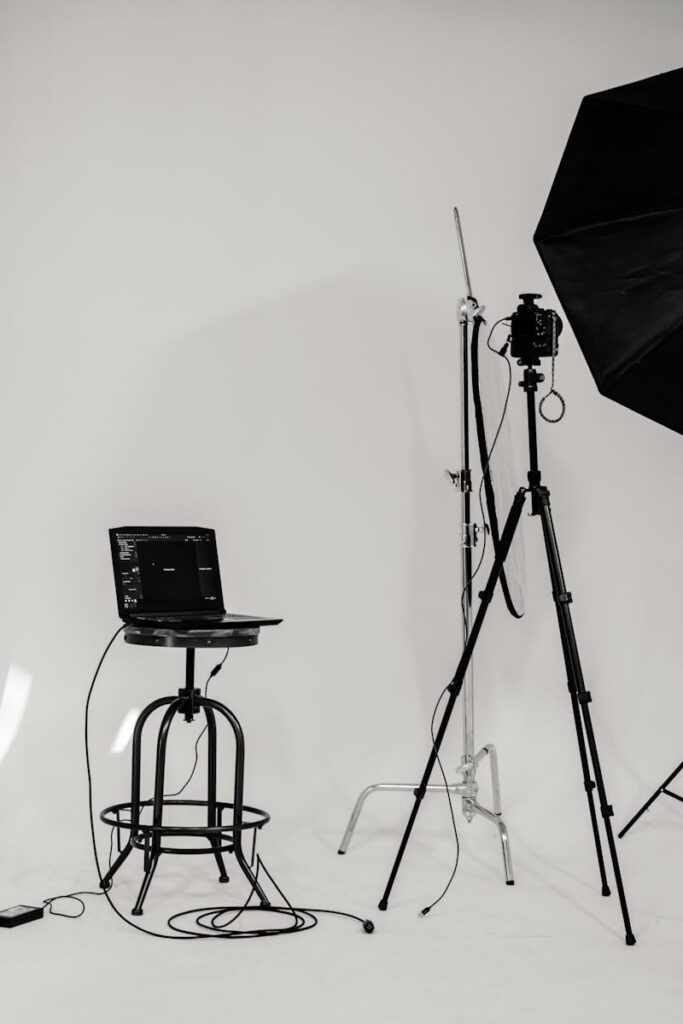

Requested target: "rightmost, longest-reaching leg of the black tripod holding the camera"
[{"left": 533, "top": 486, "right": 636, "bottom": 946}]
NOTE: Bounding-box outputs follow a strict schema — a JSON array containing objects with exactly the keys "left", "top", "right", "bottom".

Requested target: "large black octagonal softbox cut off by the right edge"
[{"left": 533, "top": 69, "right": 683, "bottom": 433}]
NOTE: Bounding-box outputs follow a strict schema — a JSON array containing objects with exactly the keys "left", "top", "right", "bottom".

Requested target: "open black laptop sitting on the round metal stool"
[{"left": 110, "top": 526, "right": 282, "bottom": 630}]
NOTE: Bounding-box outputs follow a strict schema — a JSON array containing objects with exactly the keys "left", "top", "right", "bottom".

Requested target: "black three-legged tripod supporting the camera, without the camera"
[{"left": 379, "top": 359, "right": 636, "bottom": 946}]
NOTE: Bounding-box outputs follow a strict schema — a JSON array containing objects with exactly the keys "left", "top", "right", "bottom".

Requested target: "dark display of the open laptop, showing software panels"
[{"left": 111, "top": 527, "right": 223, "bottom": 614}]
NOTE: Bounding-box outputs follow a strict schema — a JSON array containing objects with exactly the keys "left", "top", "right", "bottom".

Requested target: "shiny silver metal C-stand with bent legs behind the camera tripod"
[{"left": 339, "top": 208, "right": 514, "bottom": 886}]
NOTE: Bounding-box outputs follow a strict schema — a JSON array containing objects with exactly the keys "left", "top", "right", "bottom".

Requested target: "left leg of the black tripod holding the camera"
[{"left": 378, "top": 488, "right": 526, "bottom": 910}]
